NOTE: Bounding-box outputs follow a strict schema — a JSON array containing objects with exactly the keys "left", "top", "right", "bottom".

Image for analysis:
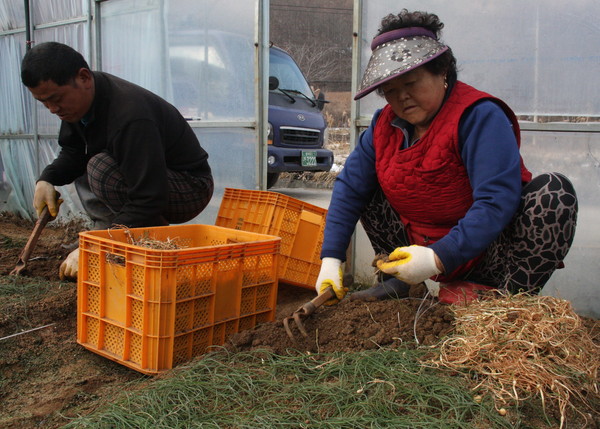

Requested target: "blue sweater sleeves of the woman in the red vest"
[{"left": 321, "top": 100, "right": 522, "bottom": 273}]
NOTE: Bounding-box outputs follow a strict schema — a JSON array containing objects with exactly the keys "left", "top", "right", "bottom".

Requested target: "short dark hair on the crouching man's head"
[{"left": 21, "top": 42, "right": 90, "bottom": 88}]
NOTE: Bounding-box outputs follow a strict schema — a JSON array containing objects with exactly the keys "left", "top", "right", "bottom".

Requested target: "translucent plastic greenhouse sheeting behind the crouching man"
[{"left": 0, "top": 0, "right": 266, "bottom": 222}]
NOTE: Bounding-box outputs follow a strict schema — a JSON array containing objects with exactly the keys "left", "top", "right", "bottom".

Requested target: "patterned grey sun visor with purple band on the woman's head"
[{"left": 354, "top": 27, "right": 448, "bottom": 100}]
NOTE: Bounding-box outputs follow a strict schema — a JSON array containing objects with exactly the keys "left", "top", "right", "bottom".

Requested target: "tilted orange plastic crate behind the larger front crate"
[{"left": 215, "top": 188, "right": 327, "bottom": 289}]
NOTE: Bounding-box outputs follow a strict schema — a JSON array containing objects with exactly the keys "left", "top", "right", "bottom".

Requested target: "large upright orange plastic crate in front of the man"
[{"left": 77, "top": 225, "right": 281, "bottom": 374}]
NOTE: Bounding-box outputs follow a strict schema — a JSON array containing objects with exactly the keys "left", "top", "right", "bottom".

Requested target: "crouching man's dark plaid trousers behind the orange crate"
[{"left": 75, "top": 153, "right": 214, "bottom": 228}]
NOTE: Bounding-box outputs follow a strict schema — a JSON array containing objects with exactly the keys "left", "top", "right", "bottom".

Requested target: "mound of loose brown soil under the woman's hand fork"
[{"left": 230, "top": 285, "right": 454, "bottom": 354}]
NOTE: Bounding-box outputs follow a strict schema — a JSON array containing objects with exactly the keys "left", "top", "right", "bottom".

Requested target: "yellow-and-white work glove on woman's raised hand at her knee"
[{"left": 377, "top": 245, "right": 442, "bottom": 285}]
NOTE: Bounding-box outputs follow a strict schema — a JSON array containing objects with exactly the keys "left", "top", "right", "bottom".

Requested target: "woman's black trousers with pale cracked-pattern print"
[{"left": 360, "top": 173, "right": 578, "bottom": 293}]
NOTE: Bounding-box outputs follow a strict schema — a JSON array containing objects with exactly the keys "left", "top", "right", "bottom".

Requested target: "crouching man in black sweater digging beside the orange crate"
[{"left": 21, "top": 42, "right": 213, "bottom": 279}]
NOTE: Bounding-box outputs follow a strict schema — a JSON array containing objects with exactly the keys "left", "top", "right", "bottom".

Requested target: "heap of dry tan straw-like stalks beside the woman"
[{"left": 424, "top": 294, "right": 600, "bottom": 427}]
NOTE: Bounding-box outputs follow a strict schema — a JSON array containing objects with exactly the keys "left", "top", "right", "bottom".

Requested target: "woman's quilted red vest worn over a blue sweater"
[{"left": 373, "top": 82, "right": 531, "bottom": 281}]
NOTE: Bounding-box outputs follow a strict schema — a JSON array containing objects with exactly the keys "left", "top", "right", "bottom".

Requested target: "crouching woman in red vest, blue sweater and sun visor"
[{"left": 316, "top": 9, "right": 577, "bottom": 302}]
